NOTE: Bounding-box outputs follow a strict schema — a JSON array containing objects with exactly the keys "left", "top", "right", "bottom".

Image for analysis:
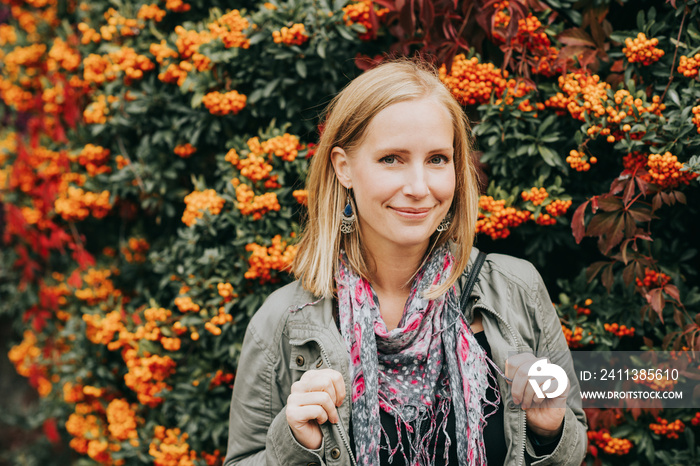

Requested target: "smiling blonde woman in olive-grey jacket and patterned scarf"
[{"left": 225, "top": 61, "right": 586, "bottom": 466}]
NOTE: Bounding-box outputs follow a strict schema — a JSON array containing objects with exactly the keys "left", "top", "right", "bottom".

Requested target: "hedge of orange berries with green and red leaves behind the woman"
[{"left": 0, "top": 0, "right": 700, "bottom": 465}]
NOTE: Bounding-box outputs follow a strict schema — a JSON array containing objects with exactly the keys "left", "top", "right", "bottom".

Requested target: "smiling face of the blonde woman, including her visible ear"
[{"left": 331, "top": 97, "right": 455, "bottom": 253}]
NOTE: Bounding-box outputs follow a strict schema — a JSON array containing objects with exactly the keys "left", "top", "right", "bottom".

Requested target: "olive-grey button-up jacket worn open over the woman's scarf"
[{"left": 224, "top": 248, "right": 587, "bottom": 466}]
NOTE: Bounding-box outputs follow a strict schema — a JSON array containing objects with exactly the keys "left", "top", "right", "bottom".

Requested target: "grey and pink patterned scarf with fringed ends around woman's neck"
[{"left": 336, "top": 246, "right": 500, "bottom": 466}]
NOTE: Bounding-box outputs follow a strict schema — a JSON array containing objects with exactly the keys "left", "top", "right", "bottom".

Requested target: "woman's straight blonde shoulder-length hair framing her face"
[{"left": 292, "top": 59, "right": 479, "bottom": 298}]
